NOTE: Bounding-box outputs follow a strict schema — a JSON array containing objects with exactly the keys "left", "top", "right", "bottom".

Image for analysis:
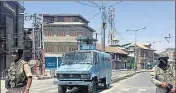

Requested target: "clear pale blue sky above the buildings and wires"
[{"left": 24, "top": 1, "right": 175, "bottom": 52}]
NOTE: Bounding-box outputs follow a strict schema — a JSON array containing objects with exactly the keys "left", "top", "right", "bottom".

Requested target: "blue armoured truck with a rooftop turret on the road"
[{"left": 54, "top": 36, "right": 112, "bottom": 93}]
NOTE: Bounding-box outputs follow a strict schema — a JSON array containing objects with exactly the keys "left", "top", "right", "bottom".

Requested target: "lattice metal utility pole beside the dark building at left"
[{"left": 25, "top": 13, "right": 43, "bottom": 74}]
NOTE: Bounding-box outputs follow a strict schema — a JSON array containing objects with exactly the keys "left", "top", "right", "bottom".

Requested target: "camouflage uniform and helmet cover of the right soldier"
[{"left": 151, "top": 54, "right": 176, "bottom": 93}]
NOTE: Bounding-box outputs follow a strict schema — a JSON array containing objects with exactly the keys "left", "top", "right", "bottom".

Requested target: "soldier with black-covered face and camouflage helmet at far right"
[{"left": 151, "top": 52, "right": 176, "bottom": 93}]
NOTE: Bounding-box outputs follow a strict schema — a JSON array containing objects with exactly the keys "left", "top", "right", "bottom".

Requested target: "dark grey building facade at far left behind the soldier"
[{"left": 0, "top": 1, "right": 24, "bottom": 74}]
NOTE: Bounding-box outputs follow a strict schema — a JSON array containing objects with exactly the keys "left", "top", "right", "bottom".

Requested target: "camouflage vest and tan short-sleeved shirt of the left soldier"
[{"left": 5, "top": 48, "right": 32, "bottom": 93}]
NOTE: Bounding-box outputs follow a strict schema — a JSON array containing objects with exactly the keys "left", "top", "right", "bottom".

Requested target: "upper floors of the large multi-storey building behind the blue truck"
[{"left": 41, "top": 14, "right": 95, "bottom": 56}]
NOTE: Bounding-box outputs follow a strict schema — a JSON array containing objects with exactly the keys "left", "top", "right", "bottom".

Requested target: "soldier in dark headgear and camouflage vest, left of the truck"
[{"left": 5, "top": 49, "right": 32, "bottom": 93}]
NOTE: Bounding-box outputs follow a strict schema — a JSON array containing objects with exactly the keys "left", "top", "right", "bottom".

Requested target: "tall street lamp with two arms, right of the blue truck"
[{"left": 127, "top": 27, "right": 146, "bottom": 68}]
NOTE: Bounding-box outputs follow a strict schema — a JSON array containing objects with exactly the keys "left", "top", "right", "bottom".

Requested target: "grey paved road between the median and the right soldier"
[{"left": 101, "top": 72, "right": 155, "bottom": 93}]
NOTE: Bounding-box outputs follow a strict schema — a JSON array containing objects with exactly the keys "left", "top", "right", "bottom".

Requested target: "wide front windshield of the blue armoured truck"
[{"left": 63, "top": 52, "right": 92, "bottom": 64}]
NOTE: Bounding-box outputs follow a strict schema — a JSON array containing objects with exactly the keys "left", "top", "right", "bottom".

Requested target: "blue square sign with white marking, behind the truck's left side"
[{"left": 45, "top": 57, "right": 57, "bottom": 69}]
